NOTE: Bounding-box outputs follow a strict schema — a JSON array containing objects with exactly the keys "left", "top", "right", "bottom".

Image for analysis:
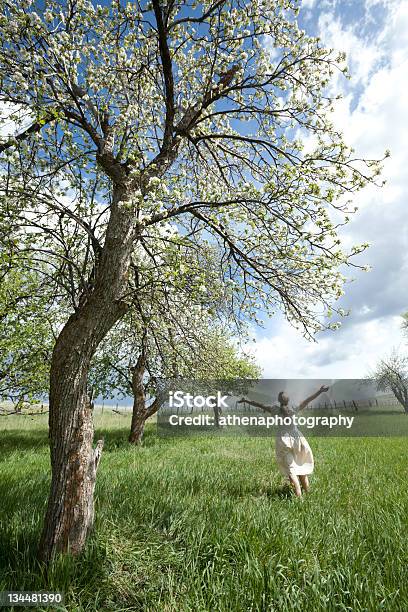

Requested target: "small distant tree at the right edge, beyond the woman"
[{"left": 370, "top": 350, "right": 408, "bottom": 414}]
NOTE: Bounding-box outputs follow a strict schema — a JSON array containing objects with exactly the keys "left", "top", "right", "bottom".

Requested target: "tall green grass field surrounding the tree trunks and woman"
[{"left": 0, "top": 413, "right": 408, "bottom": 612}]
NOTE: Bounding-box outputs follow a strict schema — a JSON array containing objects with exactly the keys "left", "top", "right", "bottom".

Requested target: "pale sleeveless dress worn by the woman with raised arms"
[{"left": 275, "top": 407, "right": 314, "bottom": 477}]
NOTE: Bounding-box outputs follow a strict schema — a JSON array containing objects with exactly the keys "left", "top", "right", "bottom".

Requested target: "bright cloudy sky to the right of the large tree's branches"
[{"left": 248, "top": 0, "right": 408, "bottom": 378}]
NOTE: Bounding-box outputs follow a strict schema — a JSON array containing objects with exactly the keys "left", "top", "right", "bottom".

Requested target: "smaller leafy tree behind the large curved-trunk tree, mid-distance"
[{"left": 91, "top": 314, "right": 260, "bottom": 444}]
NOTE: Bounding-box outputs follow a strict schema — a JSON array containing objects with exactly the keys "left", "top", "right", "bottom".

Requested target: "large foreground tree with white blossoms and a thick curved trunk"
[{"left": 0, "top": 0, "right": 379, "bottom": 561}]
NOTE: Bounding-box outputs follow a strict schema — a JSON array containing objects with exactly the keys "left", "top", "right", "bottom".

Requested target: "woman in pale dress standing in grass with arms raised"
[{"left": 275, "top": 386, "right": 329, "bottom": 497}]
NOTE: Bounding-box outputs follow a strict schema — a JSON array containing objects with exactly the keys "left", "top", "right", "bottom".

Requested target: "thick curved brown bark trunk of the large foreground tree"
[{"left": 40, "top": 190, "right": 135, "bottom": 562}]
